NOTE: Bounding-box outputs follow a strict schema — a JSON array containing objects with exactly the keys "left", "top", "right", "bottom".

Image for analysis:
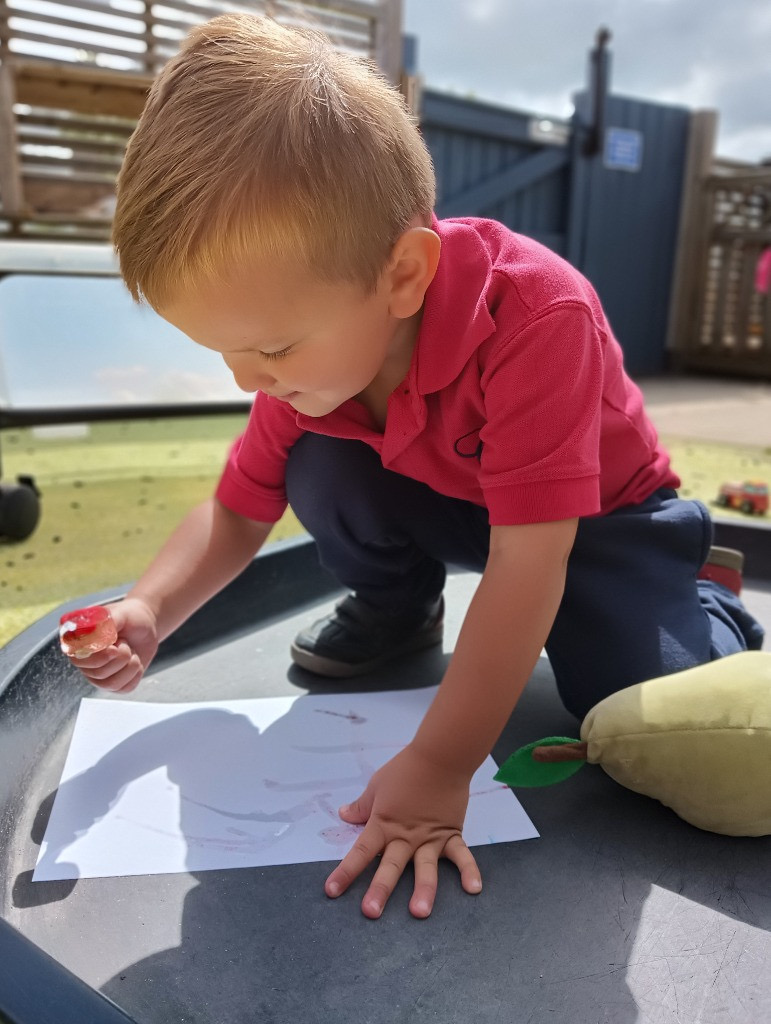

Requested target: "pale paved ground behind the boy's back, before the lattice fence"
[{"left": 638, "top": 377, "right": 771, "bottom": 447}]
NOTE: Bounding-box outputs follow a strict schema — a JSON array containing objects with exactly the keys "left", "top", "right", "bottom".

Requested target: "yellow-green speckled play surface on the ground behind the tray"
[{"left": 0, "top": 415, "right": 771, "bottom": 644}]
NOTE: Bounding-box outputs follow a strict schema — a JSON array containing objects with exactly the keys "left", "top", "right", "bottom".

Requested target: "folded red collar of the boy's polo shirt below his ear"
[{"left": 414, "top": 216, "right": 496, "bottom": 394}]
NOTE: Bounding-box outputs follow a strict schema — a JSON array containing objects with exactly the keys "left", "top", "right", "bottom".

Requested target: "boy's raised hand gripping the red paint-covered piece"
[{"left": 70, "top": 597, "right": 159, "bottom": 693}]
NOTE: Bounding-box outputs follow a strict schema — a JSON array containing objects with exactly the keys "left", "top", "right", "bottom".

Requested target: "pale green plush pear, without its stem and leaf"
[{"left": 581, "top": 651, "right": 771, "bottom": 836}]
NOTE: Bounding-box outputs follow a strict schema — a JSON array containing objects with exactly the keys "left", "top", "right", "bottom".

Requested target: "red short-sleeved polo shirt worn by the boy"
[{"left": 217, "top": 212, "right": 680, "bottom": 525}]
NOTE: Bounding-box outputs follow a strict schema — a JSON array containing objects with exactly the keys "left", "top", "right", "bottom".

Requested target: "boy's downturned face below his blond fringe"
[{"left": 159, "top": 256, "right": 412, "bottom": 416}]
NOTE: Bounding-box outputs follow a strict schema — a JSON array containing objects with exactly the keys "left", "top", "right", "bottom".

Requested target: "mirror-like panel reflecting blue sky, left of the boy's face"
[{"left": 0, "top": 274, "right": 241, "bottom": 410}]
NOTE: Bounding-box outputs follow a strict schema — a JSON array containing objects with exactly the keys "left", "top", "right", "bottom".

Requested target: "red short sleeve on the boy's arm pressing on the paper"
[{"left": 479, "top": 301, "right": 604, "bottom": 525}]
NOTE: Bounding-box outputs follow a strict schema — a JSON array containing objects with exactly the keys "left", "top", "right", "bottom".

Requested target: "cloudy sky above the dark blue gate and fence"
[{"left": 403, "top": 0, "right": 771, "bottom": 162}]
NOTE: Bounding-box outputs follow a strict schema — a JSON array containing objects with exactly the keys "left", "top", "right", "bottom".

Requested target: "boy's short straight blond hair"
[{"left": 113, "top": 14, "right": 435, "bottom": 308}]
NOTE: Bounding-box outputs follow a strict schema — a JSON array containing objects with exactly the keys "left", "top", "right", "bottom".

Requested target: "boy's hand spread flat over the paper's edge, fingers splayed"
[{"left": 325, "top": 744, "right": 482, "bottom": 918}]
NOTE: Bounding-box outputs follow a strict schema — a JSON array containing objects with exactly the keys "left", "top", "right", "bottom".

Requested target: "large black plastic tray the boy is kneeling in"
[{"left": 0, "top": 526, "right": 771, "bottom": 1024}]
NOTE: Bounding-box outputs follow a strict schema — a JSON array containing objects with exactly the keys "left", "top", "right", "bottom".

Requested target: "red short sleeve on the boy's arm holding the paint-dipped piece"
[{"left": 216, "top": 392, "right": 303, "bottom": 522}]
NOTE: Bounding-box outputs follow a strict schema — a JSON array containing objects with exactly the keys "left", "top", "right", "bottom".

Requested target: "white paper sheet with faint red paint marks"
[{"left": 33, "top": 687, "right": 538, "bottom": 882}]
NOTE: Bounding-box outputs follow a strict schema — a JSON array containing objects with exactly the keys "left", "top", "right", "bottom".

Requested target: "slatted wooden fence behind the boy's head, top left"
[{"left": 0, "top": 0, "right": 401, "bottom": 241}]
